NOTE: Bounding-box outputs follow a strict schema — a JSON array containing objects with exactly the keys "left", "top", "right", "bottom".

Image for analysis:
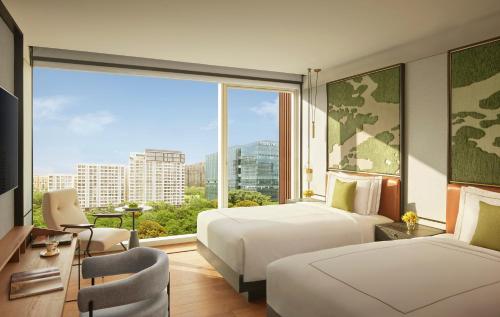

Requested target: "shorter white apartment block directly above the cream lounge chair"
[{"left": 76, "top": 164, "right": 127, "bottom": 208}]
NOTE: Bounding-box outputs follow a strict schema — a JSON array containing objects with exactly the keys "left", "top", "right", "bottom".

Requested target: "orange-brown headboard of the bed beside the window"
[{"left": 325, "top": 171, "right": 401, "bottom": 221}]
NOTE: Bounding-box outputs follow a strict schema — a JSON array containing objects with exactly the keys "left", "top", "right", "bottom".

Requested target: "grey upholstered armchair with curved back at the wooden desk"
[{"left": 78, "top": 247, "right": 170, "bottom": 317}]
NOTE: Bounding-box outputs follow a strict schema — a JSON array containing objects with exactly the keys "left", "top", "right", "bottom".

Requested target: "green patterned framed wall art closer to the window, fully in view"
[{"left": 327, "top": 64, "right": 404, "bottom": 176}]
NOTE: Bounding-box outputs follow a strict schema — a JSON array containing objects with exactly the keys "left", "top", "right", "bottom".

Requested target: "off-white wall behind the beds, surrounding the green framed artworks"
[{"left": 302, "top": 15, "right": 500, "bottom": 227}]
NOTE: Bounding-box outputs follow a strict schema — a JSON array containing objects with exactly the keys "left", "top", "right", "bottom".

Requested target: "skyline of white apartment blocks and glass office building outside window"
[{"left": 33, "top": 140, "right": 279, "bottom": 209}]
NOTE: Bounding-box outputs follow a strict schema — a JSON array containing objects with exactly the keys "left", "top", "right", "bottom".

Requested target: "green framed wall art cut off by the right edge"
[{"left": 448, "top": 38, "right": 500, "bottom": 186}]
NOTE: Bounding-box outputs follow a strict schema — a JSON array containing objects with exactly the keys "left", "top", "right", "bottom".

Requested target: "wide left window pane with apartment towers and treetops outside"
[{"left": 33, "top": 67, "right": 217, "bottom": 238}]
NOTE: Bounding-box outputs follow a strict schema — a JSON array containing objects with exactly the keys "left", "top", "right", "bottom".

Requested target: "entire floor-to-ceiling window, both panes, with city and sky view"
[{"left": 33, "top": 67, "right": 296, "bottom": 238}]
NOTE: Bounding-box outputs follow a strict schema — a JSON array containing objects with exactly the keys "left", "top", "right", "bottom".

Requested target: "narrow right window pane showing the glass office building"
[{"left": 227, "top": 88, "right": 279, "bottom": 206}]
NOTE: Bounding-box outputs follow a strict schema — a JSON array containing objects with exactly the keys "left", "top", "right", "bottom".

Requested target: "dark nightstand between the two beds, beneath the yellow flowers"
[{"left": 375, "top": 222, "right": 445, "bottom": 241}]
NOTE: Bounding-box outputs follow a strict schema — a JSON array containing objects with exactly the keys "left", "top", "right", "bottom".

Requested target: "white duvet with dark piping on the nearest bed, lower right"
[{"left": 267, "top": 237, "right": 500, "bottom": 317}]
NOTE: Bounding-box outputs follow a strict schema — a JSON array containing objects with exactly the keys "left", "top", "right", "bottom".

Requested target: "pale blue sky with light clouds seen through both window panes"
[{"left": 33, "top": 67, "right": 278, "bottom": 175}]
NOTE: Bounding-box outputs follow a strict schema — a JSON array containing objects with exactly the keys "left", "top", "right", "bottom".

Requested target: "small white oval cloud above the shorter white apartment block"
[{"left": 68, "top": 111, "right": 115, "bottom": 135}]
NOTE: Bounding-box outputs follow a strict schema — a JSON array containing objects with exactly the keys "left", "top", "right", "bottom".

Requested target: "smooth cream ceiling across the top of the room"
[{"left": 3, "top": 0, "right": 500, "bottom": 74}]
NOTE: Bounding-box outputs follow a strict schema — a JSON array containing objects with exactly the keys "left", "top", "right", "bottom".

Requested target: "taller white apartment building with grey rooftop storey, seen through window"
[{"left": 128, "top": 149, "right": 185, "bottom": 206}]
